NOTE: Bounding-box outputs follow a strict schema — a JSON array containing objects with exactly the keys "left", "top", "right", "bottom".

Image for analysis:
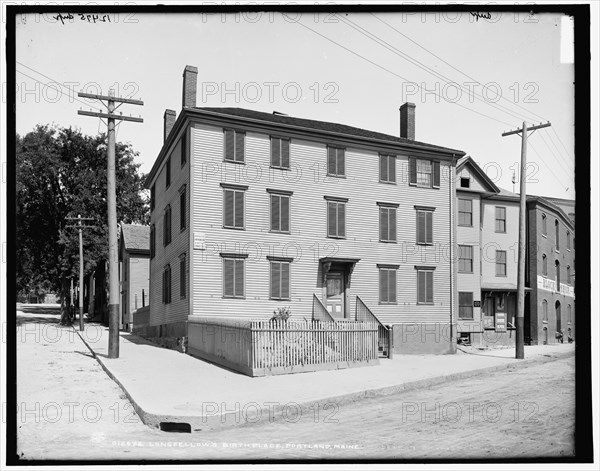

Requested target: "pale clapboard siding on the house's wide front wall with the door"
[{"left": 190, "top": 124, "right": 453, "bottom": 323}]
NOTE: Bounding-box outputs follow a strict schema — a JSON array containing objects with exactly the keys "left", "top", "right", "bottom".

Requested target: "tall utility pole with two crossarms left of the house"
[{"left": 77, "top": 89, "right": 144, "bottom": 358}]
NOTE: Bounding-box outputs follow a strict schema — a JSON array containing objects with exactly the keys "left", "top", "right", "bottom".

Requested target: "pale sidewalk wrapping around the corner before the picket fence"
[{"left": 77, "top": 324, "right": 575, "bottom": 431}]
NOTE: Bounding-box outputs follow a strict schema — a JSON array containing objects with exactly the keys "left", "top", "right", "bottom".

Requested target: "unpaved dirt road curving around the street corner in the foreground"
[{"left": 17, "top": 308, "right": 575, "bottom": 460}]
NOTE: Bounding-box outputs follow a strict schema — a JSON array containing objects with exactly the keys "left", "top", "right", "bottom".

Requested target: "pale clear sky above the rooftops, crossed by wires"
[{"left": 10, "top": 5, "right": 575, "bottom": 198}]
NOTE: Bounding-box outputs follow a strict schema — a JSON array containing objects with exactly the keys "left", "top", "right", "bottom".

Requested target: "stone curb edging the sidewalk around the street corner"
[{"left": 74, "top": 329, "right": 575, "bottom": 432}]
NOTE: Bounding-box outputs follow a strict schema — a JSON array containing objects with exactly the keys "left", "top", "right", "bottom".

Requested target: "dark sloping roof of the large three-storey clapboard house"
[{"left": 194, "top": 107, "right": 464, "bottom": 155}]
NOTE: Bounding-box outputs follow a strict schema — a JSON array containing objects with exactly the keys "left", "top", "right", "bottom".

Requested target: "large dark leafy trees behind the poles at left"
[{"left": 16, "top": 125, "right": 149, "bottom": 324}]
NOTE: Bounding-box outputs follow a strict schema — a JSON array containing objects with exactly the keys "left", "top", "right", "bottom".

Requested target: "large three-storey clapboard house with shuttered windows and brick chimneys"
[{"left": 146, "top": 66, "right": 464, "bottom": 353}]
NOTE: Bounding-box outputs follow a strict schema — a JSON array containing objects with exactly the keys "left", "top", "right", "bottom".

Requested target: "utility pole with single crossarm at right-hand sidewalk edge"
[{"left": 502, "top": 121, "right": 550, "bottom": 360}]
